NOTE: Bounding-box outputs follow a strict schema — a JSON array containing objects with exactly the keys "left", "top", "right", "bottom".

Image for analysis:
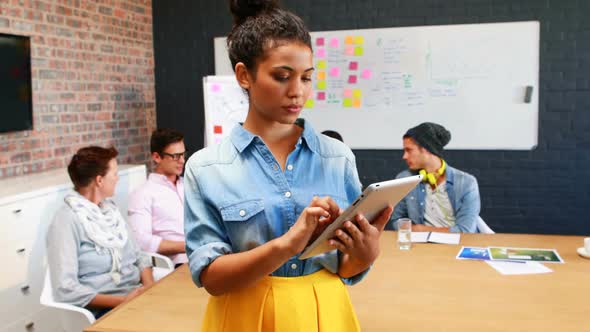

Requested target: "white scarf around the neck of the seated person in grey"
[{"left": 64, "top": 193, "right": 127, "bottom": 285}]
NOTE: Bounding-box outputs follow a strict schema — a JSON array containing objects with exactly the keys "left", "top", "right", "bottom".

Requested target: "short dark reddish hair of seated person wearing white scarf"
[{"left": 68, "top": 146, "right": 119, "bottom": 190}]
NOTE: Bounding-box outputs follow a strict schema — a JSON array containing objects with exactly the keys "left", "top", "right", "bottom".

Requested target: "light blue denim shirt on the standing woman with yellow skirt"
[{"left": 184, "top": 119, "right": 367, "bottom": 287}]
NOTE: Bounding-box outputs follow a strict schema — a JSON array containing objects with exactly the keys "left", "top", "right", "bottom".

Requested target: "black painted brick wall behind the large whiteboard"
[{"left": 153, "top": 0, "right": 590, "bottom": 235}]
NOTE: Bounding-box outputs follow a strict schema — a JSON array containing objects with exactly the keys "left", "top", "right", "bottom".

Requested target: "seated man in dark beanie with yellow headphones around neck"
[{"left": 386, "top": 122, "right": 480, "bottom": 233}]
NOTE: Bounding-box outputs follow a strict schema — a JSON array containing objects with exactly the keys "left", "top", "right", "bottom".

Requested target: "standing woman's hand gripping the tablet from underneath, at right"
[{"left": 330, "top": 206, "right": 393, "bottom": 264}]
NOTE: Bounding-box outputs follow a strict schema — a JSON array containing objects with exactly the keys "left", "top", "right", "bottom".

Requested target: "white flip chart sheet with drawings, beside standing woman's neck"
[{"left": 203, "top": 76, "right": 248, "bottom": 146}]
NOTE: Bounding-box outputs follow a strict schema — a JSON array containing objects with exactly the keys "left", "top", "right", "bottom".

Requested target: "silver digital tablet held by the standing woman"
[{"left": 299, "top": 175, "right": 422, "bottom": 259}]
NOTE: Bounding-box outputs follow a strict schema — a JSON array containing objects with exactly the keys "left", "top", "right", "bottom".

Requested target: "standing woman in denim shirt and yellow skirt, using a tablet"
[{"left": 185, "top": 0, "right": 392, "bottom": 331}]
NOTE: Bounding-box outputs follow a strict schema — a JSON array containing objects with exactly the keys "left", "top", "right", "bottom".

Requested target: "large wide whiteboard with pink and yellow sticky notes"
[{"left": 213, "top": 21, "right": 540, "bottom": 150}]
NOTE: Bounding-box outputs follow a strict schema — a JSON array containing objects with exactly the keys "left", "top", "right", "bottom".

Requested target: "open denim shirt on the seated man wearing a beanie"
[{"left": 385, "top": 166, "right": 480, "bottom": 233}]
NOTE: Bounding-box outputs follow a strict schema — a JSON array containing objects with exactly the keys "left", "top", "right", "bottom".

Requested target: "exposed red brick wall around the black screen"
[{"left": 0, "top": 0, "right": 156, "bottom": 178}]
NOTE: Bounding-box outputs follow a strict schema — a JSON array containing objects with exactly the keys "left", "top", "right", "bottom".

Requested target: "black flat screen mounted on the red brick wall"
[{"left": 0, "top": 33, "right": 33, "bottom": 133}]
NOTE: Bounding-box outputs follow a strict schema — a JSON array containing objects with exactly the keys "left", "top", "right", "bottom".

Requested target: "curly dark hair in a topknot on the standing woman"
[{"left": 227, "top": 0, "right": 312, "bottom": 77}]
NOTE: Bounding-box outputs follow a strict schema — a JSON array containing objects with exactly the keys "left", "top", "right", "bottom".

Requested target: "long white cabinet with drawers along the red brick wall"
[{"left": 0, "top": 165, "right": 146, "bottom": 332}]
